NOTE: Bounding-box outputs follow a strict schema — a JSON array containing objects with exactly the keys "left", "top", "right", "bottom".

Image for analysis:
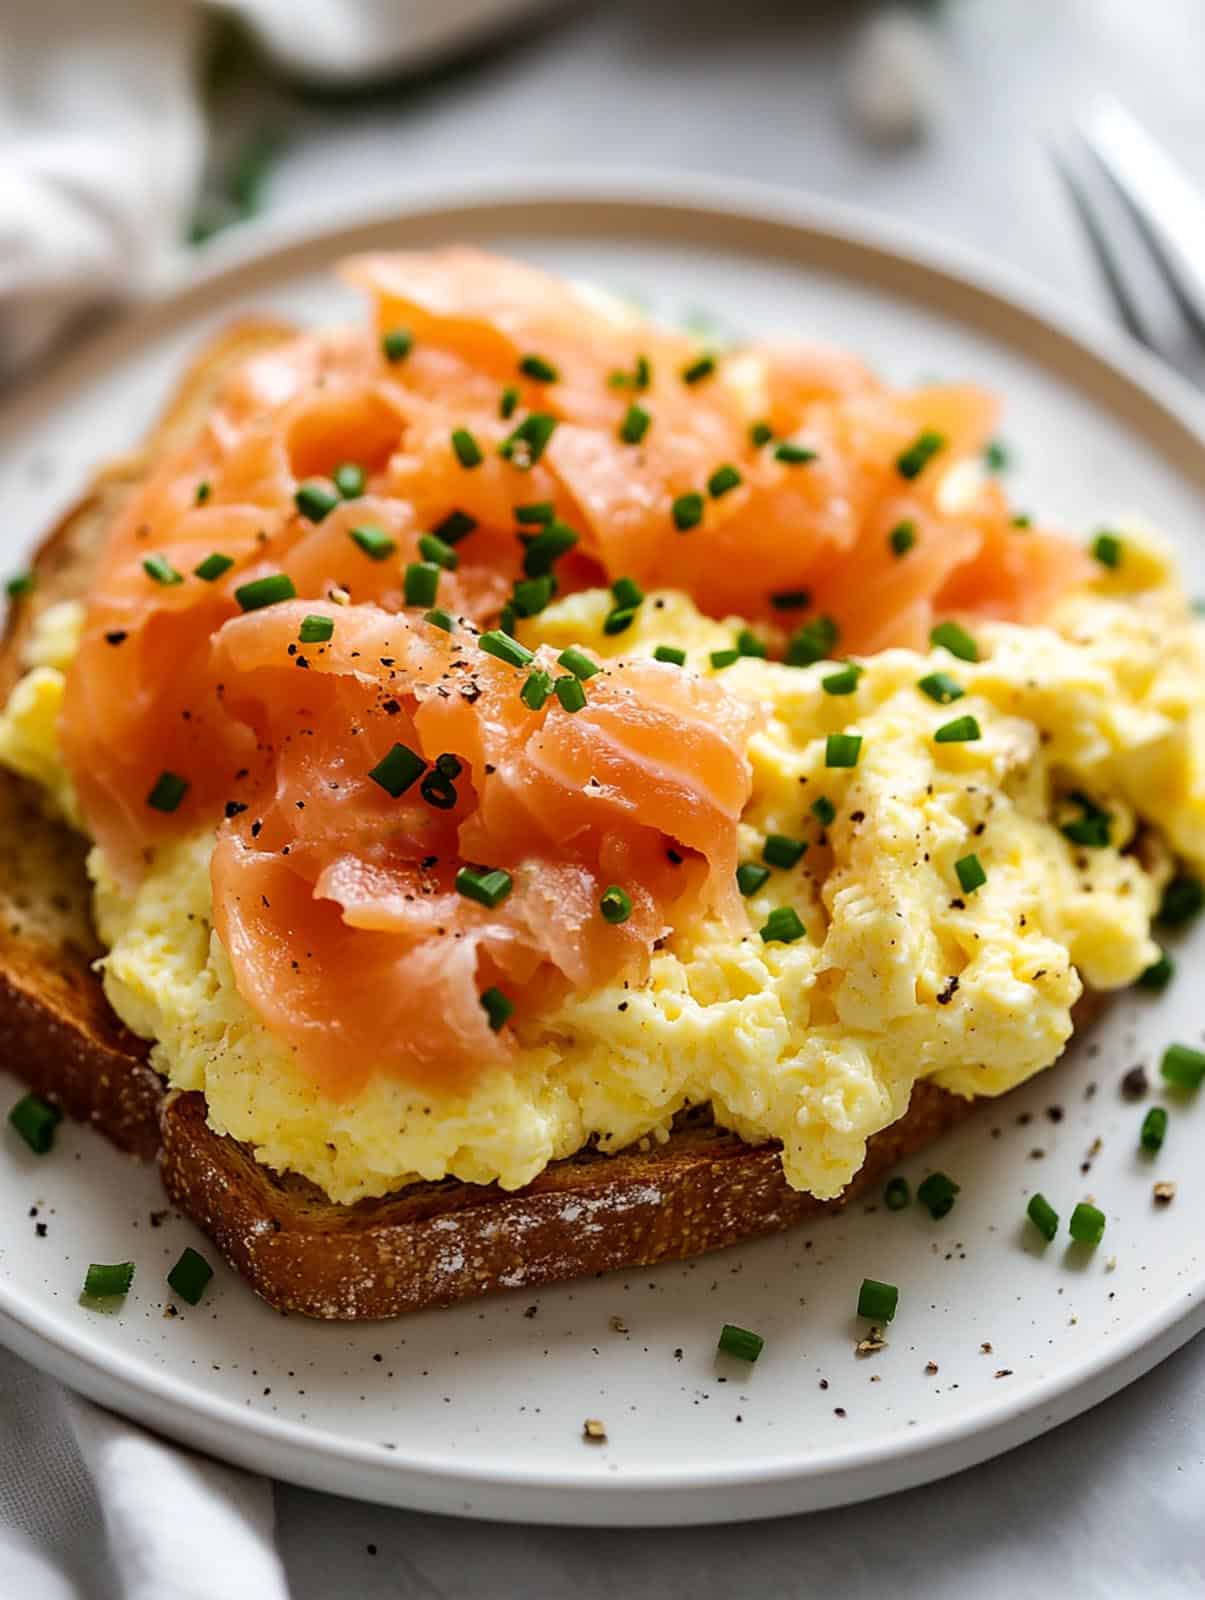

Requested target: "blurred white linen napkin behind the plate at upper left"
[{"left": 0, "top": 0, "right": 539, "bottom": 379}]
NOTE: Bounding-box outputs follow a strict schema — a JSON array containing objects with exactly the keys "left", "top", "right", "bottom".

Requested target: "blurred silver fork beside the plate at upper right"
[{"left": 1055, "top": 99, "right": 1205, "bottom": 386}]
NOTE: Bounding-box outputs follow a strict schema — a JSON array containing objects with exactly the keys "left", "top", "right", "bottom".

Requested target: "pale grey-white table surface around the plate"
[{"left": 18, "top": 0, "right": 1205, "bottom": 1600}]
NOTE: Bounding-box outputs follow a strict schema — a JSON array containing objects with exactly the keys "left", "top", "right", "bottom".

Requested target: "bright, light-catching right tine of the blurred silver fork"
[{"left": 1079, "top": 99, "right": 1205, "bottom": 342}]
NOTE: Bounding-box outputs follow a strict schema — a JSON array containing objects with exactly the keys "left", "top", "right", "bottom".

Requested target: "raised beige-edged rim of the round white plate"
[{"left": 0, "top": 168, "right": 1205, "bottom": 1526}]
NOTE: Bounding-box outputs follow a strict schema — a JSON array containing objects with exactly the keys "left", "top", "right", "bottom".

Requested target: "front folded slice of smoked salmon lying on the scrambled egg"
[{"left": 204, "top": 602, "right": 759, "bottom": 1093}]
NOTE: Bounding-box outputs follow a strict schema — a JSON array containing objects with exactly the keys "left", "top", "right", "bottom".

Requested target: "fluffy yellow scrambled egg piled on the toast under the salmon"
[{"left": 0, "top": 536, "right": 1205, "bottom": 1202}]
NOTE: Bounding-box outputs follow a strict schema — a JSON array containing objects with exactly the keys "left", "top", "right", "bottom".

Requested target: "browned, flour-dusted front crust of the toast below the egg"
[{"left": 160, "top": 1083, "right": 975, "bottom": 1322}]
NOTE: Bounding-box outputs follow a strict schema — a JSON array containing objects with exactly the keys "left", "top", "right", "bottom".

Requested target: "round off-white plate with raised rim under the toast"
[{"left": 0, "top": 178, "right": 1205, "bottom": 1523}]
